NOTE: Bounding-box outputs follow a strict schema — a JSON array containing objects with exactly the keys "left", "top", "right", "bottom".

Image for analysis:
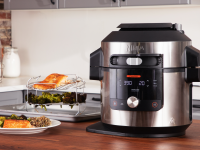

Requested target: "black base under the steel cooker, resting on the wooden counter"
[{"left": 86, "top": 121, "right": 190, "bottom": 138}]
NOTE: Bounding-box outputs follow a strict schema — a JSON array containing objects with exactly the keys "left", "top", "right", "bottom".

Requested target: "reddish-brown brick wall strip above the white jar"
[{"left": 0, "top": 10, "right": 12, "bottom": 46}]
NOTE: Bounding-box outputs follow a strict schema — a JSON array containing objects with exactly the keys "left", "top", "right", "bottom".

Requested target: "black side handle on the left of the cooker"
[{"left": 90, "top": 48, "right": 103, "bottom": 80}]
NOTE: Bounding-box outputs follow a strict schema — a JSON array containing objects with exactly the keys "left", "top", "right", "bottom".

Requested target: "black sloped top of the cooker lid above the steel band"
[{"left": 102, "top": 23, "right": 191, "bottom": 42}]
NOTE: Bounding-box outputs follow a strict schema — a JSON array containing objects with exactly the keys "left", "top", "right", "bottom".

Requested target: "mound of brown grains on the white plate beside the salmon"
[{"left": 30, "top": 116, "right": 51, "bottom": 127}]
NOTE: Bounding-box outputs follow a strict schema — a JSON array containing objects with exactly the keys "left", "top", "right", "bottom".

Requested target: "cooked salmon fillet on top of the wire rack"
[{"left": 33, "top": 73, "right": 70, "bottom": 90}]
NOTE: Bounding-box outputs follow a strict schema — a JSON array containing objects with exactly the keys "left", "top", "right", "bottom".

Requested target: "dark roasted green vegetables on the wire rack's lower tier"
[{"left": 25, "top": 92, "right": 87, "bottom": 108}]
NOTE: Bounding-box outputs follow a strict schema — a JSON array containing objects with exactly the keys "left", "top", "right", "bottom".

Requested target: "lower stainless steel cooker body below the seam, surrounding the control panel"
[{"left": 101, "top": 72, "right": 191, "bottom": 127}]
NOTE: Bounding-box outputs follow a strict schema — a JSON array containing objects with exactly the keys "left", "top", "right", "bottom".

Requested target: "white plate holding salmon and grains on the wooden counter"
[{"left": 0, "top": 119, "right": 61, "bottom": 134}]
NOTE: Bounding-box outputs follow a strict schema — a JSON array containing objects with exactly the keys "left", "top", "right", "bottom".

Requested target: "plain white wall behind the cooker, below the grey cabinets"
[{"left": 12, "top": 6, "right": 200, "bottom": 79}]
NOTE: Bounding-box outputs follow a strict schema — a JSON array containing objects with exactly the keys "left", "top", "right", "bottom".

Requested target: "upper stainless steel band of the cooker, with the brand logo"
[{"left": 101, "top": 41, "right": 192, "bottom": 68}]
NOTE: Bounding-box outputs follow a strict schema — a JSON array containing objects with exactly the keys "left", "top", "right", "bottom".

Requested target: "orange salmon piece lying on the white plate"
[{"left": 3, "top": 119, "right": 32, "bottom": 128}]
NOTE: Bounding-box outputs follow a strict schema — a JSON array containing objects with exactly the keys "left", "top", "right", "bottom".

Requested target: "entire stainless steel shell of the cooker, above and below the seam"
[{"left": 101, "top": 41, "right": 192, "bottom": 127}]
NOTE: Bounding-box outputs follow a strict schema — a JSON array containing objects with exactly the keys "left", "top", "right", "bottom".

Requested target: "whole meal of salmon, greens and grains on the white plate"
[{"left": 0, "top": 114, "right": 51, "bottom": 128}]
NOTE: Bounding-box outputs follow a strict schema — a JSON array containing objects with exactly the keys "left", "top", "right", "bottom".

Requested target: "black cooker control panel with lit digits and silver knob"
[{"left": 110, "top": 68, "right": 163, "bottom": 111}]
